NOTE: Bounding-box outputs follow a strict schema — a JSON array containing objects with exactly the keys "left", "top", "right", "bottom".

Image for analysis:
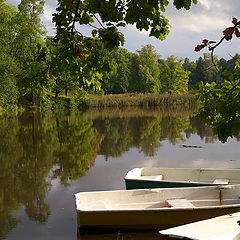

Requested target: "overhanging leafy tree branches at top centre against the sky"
[{"left": 53, "top": 0, "right": 197, "bottom": 90}]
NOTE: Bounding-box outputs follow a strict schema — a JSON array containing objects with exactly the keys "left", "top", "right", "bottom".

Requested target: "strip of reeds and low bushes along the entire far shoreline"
[{"left": 0, "top": 94, "right": 198, "bottom": 116}]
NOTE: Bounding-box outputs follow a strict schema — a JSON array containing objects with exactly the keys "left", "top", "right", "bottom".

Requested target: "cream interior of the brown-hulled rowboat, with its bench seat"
[{"left": 76, "top": 185, "right": 240, "bottom": 210}]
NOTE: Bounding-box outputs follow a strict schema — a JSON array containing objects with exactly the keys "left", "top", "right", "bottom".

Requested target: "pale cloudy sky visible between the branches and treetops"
[{"left": 7, "top": 0, "right": 240, "bottom": 61}]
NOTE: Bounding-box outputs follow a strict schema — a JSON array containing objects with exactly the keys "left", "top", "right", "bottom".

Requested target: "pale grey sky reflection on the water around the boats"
[{"left": 4, "top": 131, "right": 240, "bottom": 240}]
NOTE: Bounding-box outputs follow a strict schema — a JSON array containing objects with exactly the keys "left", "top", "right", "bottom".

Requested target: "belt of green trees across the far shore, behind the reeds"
[{"left": 0, "top": 1, "right": 240, "bottom": 112}]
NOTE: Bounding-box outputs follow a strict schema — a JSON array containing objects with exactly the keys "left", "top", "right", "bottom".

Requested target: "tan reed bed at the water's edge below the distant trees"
[{"left": 82, "top": 94, "right": 198, "bottom": 108}]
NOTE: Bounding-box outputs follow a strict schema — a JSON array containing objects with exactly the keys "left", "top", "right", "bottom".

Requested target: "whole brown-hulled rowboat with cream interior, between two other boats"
[{"left": 75, "top": 185, "right": 240, "bottom": 230}]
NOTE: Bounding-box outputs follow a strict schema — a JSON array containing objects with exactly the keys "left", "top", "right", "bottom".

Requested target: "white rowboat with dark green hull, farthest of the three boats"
[{"left": 124, "top": 168, "right": 240, "bottom": 189}]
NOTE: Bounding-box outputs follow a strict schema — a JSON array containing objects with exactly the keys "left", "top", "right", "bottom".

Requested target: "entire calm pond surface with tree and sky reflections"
[{"left": 0, "top": 109, "right": 240, "bottom": 240}]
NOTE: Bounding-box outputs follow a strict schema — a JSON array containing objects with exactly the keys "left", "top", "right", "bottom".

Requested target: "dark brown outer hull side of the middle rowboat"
[{"left": 77, "top": 206, "right": 240, "bottom": 230}]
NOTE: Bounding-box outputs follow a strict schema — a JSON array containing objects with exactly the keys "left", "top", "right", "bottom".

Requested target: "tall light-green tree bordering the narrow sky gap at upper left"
[{"left": 14, "top": 0, "right": 46, "bottom": 103}]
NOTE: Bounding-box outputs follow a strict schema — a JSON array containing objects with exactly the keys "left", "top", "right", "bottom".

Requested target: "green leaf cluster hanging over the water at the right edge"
[{"left": 198, "top": 63, "right": 240, "bottom": 142}]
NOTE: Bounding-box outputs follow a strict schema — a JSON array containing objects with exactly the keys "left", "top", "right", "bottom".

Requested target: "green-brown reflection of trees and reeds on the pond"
[{"left": 0, "top": 109, "right": 234, "bottom": 239}]
